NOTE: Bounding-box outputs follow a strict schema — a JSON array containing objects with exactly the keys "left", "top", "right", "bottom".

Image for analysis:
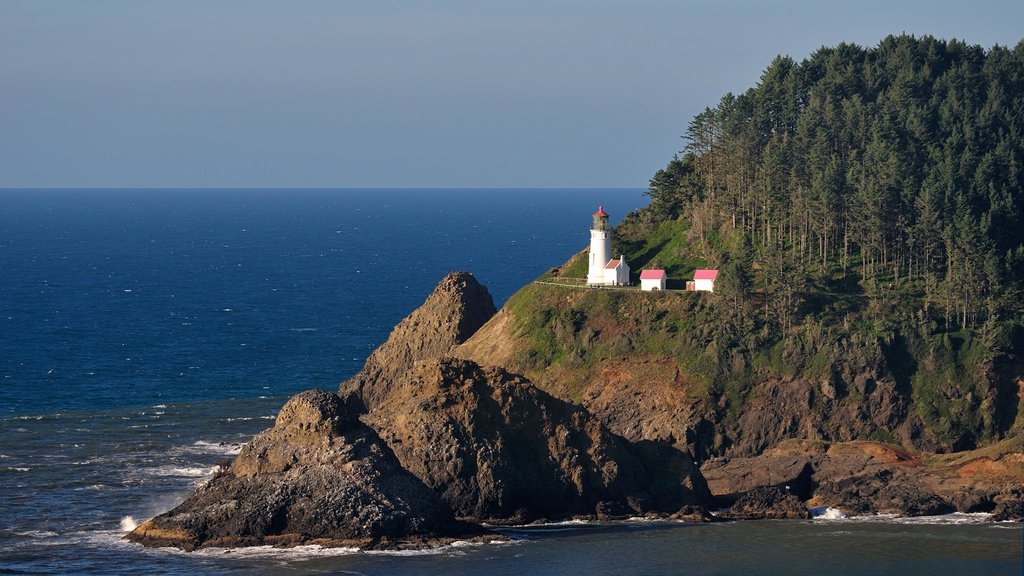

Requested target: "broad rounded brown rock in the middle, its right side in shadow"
[{"left": 364, "top": 358, "right": 708, "bottom": 523}]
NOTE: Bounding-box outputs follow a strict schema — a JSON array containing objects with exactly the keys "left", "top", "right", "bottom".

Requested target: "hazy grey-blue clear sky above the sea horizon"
[{"left": 0, "top": 0, "right": 1024, "bottom": 188}]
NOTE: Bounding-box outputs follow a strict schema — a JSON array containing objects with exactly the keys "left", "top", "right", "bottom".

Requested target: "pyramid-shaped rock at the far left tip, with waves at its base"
[{"left": 127, "top": 390, "right": 483, "bottom": 550}]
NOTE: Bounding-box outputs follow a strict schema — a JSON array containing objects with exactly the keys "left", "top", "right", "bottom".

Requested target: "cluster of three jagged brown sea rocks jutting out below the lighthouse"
[{"left": 127, "top": 273, "right": 710, "bottom": 549}]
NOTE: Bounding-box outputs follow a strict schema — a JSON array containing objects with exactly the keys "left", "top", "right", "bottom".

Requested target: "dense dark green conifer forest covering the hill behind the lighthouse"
[{"left": 638, "top": 35, "right": 1024, "bottom": 330}]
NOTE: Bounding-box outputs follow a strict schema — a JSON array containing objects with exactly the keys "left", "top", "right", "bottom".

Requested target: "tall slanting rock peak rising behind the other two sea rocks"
[{"left": 338, "top": 272, "right": 497, "bottom": 409}]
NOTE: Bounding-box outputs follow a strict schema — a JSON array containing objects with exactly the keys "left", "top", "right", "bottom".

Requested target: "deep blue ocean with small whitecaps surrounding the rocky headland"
[{"left": 0, "top": 189, "right": 1024, "bottom": 576}]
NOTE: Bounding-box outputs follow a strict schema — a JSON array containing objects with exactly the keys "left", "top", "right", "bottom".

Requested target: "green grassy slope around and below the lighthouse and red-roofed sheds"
[{"left": 465, "top": 213, "right": 1024, "bottom": 450}]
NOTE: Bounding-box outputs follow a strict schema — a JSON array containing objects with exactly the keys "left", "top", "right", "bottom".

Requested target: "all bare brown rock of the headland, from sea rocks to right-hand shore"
[{"left": 127, "top": 273, "right": 1024, "bottom": 549}]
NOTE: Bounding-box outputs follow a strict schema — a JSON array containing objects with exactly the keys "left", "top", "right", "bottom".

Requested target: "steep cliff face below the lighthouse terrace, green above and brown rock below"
[{"left": 453, "top": 280, "right": 1022, "bottom": 460}]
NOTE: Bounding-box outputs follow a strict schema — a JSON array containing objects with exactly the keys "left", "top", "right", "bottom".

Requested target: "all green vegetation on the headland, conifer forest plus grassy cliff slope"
[{"left": 509, "top": 36, "right": 1024, "bottom": 452}]
